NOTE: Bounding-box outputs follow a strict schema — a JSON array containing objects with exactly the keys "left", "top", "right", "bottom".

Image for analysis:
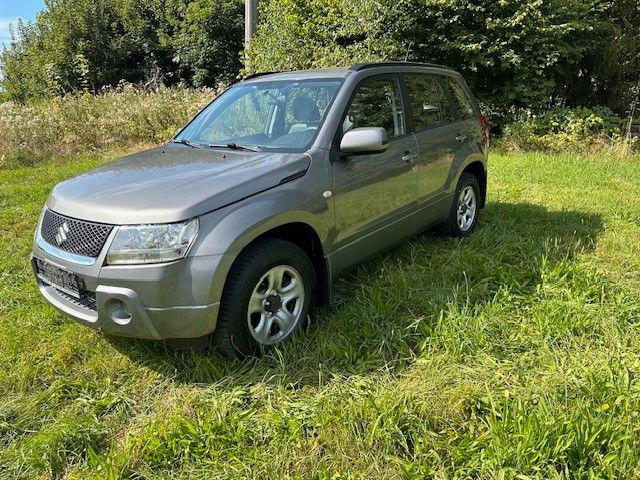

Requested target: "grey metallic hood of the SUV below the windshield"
[{"left": 47, "top": 145, "right": 311, "bottom": 225}]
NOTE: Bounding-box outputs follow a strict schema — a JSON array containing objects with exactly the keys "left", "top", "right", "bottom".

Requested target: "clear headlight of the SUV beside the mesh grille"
[{"left": 107, "top": 218, "right": 198, "bottom": 265}]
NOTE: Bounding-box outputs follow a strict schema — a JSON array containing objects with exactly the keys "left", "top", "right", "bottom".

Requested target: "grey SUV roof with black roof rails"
[{"left": 244, "top": 62, "right": 453, "bottom": 82}]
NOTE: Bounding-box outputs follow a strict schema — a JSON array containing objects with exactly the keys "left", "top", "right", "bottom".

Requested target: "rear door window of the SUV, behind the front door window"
[{"left": 406, "top": 73, "right": 450, "bottom": 132}]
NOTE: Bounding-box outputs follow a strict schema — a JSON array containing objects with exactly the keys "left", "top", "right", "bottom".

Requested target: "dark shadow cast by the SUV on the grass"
[{"left": 109, "top": 202, "right": 604, "bottom": 388}]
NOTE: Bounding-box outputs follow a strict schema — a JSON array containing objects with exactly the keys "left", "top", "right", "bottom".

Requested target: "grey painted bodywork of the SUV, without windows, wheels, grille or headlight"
[{"left": 33, "top": 65, "right": 487, "bottom": 339}]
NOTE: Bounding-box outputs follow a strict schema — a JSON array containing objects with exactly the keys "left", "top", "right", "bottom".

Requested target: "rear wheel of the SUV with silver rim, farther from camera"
[{"left": 438, "top": 172, "right": 481, "bottom": 237}]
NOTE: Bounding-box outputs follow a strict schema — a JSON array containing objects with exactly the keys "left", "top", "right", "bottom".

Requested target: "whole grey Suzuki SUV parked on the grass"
[{"left": 32, "top": 62, "right": 488, "bottom": 356}]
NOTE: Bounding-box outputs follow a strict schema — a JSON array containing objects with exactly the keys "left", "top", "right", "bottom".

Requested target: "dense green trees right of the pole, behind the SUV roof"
[{"left": 251, "top": 0, "right": 640, "bottom": 125}]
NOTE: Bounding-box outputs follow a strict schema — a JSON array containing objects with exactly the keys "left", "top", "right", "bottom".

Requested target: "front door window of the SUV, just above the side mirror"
[{"left": 342, "top": 77, "right": 406, "bottom": 138}]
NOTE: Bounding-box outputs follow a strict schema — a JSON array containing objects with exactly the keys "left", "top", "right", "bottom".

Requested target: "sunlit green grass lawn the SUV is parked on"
[{"left": 0, "top": 148, "right": 640, "bottom": 479}]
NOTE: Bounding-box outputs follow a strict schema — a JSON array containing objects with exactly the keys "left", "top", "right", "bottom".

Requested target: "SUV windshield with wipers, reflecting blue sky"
[{"left": 175, "top": 80, "right": 341, "bottom": 151}]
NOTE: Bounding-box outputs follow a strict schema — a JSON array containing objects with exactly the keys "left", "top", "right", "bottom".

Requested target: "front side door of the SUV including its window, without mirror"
[{"left": 333, "top": 75, "right": 417, "bottom": 269}]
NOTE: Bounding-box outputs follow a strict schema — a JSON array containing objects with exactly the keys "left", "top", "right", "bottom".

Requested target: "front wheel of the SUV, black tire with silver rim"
[{"left": 213, "top": 239, "right": 315, "bottom": 358}]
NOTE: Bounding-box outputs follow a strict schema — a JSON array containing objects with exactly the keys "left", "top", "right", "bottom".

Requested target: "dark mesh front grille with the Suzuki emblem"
[{"left": 40, "top": 210, "right": 113, "bottom": 258}]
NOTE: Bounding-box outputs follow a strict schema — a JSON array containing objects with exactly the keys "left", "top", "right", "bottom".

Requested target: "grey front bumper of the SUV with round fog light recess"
[{"left": 33, "top": 233, "right": 220, "bottom": 340}]
